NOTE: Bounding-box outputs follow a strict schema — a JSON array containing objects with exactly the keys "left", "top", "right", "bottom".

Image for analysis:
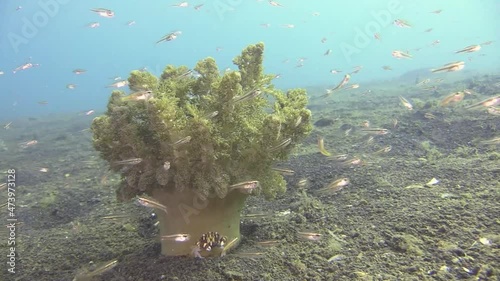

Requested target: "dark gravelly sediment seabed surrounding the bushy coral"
[{"left": 0, "top": 77, "right": 500, "bottom": 281}]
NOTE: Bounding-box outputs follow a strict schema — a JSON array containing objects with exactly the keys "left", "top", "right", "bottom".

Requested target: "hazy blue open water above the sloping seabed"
[{"left": 0, "top": 0, "right": 500, "bottom": 118}]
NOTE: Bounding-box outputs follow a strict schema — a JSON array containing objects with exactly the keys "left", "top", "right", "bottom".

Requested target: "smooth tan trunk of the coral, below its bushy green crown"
[{"left": 152, "top": 189, "right": 247, "bottom": 256}]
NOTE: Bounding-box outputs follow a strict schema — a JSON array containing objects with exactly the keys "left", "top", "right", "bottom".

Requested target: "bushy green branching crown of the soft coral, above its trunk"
[{"left": 92, "top": 43, "right": 312, "bottom": 198}]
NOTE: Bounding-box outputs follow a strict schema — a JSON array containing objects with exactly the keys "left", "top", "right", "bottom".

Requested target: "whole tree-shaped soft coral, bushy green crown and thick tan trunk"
[{"left": 91, "top": 43, "right": 312, "bottom": 256}]
